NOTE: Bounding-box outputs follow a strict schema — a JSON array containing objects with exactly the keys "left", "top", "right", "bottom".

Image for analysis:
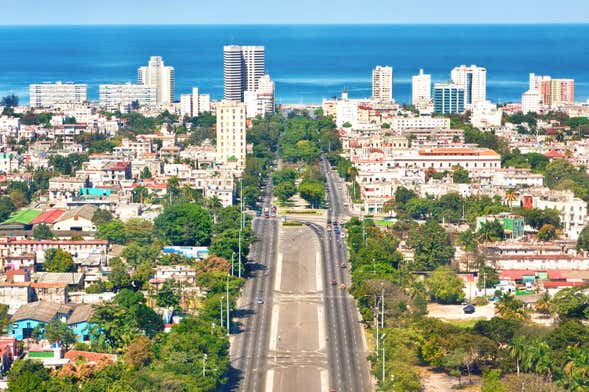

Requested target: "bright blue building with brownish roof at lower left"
[{"left": 8, "top": 301, "right": 95, "bottom": 342}]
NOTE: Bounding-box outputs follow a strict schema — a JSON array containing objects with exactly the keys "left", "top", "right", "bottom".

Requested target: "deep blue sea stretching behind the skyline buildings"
[{"left": 0, "top": 24, "right": 589, "bottom": 104}]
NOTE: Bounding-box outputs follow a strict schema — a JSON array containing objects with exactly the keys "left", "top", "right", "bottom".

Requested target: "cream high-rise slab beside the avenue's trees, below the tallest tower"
[{"left": 216, "top": 100, "right": 246, "bottom": 168}]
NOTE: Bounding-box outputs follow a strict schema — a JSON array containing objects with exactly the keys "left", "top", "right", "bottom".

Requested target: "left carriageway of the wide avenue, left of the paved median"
[{"left": 224, "top": 183, "right": 278, "bottom": 391}]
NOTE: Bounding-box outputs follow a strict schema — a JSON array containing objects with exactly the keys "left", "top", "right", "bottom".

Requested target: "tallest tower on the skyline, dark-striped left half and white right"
[{"left": 223, "top": 45, "right": 264, "bottom": 102}]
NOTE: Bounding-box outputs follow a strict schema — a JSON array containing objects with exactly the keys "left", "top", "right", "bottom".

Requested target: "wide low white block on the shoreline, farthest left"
[{"left": 29, "top": 82, "right": 88, "bottom": 108}]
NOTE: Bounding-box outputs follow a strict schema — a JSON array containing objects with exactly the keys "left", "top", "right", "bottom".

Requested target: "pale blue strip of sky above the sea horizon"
[{"left": 0, "top": 0, "right": 589, "bottom": 25}]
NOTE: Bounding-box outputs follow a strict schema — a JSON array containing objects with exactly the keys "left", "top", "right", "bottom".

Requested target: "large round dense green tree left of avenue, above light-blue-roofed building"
[{"left": 154, "top": 203, "right": 212, "bottom": 246}]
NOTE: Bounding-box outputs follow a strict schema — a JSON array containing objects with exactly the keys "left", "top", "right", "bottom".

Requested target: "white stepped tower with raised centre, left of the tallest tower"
[{"left": 137, "top": 56, "right": 175, "bottom": 105}]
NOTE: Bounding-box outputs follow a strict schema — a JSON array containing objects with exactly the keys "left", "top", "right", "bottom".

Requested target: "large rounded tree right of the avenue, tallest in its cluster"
[{"left": 408, "top": 220, "right": 454, "bottom": 270}]
